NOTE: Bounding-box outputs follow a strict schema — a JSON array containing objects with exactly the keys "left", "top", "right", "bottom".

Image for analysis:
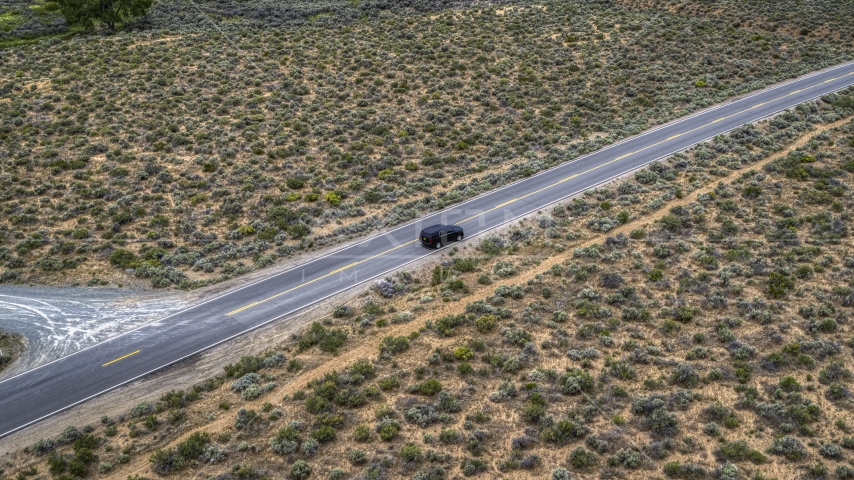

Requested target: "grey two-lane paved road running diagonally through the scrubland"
[{"left": 0, "top": 63, "right": 854, "bottom": 437}]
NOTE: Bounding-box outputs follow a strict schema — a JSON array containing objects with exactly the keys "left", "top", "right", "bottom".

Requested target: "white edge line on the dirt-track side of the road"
[{"left": 0, "top": 78, "right": 851, "bottom": 438}]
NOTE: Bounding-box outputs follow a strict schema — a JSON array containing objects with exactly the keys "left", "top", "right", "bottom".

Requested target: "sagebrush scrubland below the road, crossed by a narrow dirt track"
[{"left": 0, "top": 92, "right": 854, "bottom": 480}]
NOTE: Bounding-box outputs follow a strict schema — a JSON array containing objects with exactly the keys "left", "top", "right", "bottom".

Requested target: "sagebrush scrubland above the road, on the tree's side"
[{"left": 0, "top": 0, "right": 854, "bottom": 289}]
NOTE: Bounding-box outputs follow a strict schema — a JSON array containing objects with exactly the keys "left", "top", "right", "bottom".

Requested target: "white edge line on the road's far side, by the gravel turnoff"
[{"left": 0, "top": 61, "right": 854, "bottom": 386}]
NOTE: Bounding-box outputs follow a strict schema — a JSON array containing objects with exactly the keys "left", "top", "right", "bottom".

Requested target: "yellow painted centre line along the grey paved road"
[{"left": 224, "top": 72, "right": 854, "bottom": 316}]
